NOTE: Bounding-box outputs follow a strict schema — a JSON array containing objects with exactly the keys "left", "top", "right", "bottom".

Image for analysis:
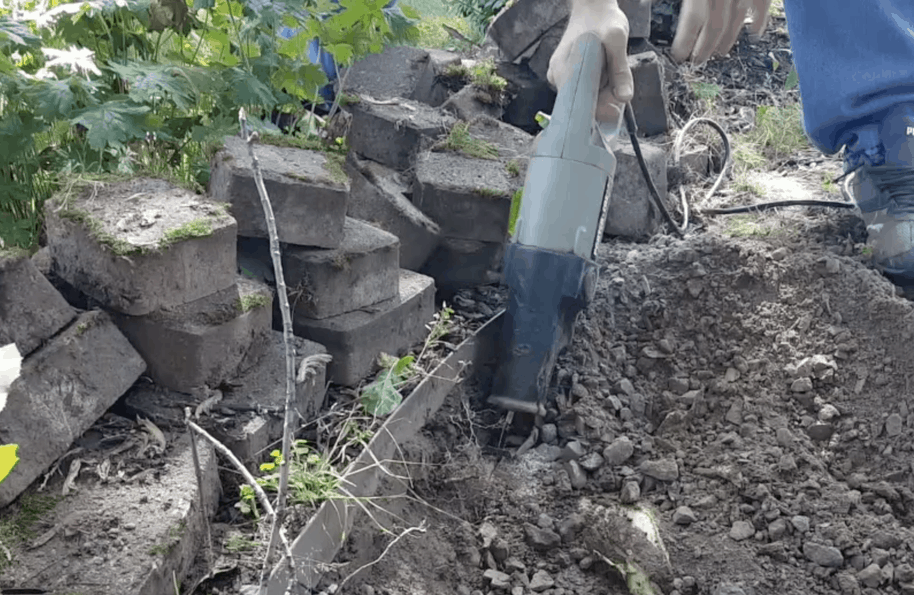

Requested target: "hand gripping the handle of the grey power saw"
[{"left": 546, "top": 0, "right": 634, "bottom": 122}]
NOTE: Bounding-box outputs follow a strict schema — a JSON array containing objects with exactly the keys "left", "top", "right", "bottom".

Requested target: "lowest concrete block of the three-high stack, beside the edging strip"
[{"left": 292, "top": 270, "right": 435, "bottom": 386}]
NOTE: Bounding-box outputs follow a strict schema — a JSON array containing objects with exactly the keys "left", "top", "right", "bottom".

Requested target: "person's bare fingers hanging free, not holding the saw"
[{"left": 672, "top": 0, "right": 771, "bottom": 64}]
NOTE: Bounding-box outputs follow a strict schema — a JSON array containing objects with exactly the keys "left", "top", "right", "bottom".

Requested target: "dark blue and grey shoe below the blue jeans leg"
[{"left": 844, "top": 104, "right": 914, "bottom": 286}]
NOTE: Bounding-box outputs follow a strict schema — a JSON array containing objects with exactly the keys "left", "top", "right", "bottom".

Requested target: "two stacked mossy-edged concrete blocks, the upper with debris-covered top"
[{"left": 48, "top": 178, "right": 280, "bottom": 393}]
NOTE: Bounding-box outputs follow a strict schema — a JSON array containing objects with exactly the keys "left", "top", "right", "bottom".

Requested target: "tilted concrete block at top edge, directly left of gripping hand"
[{"left": 488, "top": 0, "right": 570, "bottom": 62}]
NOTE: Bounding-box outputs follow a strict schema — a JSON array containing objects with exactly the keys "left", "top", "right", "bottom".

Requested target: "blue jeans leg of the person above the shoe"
[{"left": 784, "top": 0, "right": 914, "bottom": 154}]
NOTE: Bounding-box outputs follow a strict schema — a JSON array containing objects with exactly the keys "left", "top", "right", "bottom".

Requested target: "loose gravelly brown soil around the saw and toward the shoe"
[{"left": 286, "top": 7, "right": 914, "bottom": 595}]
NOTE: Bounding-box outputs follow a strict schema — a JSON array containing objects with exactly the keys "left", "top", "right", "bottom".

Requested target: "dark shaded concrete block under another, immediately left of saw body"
[{"left": 422, "top": 238, "right": 505, "bottom": 291}]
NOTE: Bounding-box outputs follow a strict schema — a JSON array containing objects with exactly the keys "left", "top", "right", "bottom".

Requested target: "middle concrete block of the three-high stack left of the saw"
[{"left": 282, "top": 217, "right": 400, "bottom": 320}]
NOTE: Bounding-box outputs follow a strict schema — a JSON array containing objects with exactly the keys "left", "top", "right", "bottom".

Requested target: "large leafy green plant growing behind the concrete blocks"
[{"left": 0, "top": 0, "right": 418, "bottom": 246}]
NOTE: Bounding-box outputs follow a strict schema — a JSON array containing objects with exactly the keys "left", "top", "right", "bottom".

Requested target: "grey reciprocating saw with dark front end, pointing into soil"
[{"left": 488, "top": 33, "right": 622, "bottom": 415}]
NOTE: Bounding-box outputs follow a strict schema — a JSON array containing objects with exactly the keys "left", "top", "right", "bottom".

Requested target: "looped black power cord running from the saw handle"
[{"left": 623, "top": 103, "right": 856, "bottom": 237}]
